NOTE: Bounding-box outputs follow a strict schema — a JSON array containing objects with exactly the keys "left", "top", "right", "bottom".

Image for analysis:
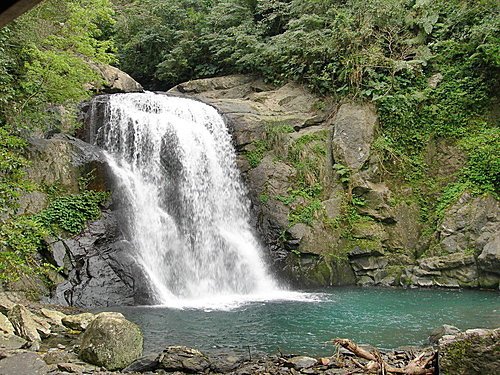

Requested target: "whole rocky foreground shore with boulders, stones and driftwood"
[{"left": 0, "top": 293, "right": 500, "bottom": 375}]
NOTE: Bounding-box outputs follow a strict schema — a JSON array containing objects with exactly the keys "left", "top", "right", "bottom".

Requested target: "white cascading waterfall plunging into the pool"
[{"left": 92, "top": 93, "right": 302, "bottom": 308}]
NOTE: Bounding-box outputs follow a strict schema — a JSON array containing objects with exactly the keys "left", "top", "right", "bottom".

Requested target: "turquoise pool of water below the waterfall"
[{"left": 107, "top": 288, "right": 500, "bottom": 356}]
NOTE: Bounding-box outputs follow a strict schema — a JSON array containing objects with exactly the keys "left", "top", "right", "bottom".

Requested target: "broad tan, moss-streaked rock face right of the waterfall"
[{"left": 169, "top": 75, "right": 500, "bottom": 288}]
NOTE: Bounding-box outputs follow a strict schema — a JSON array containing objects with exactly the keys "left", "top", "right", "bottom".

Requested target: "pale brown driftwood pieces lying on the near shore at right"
[{"left": 333, "top": 339, "right": 435, "bottom": 375}]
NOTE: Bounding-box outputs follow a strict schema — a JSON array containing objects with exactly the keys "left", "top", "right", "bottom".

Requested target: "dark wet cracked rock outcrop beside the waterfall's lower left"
[{"left": 50, "top": 210, "right": 151, "bottom": 307}]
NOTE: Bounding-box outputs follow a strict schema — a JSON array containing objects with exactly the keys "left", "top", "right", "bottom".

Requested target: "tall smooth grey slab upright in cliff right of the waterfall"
[{"left": 332, "top": 104, "right": 378, "bottom": 172}]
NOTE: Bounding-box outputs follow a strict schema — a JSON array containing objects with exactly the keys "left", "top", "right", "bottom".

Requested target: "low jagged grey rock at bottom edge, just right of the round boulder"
[{"left": 158, "top": 346, "right": 210, "bottom": 373}]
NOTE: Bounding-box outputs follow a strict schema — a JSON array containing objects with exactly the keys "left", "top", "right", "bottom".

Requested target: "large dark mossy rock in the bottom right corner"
[{"left": 438, "top": 329, "right": 500, "bottom": 375}]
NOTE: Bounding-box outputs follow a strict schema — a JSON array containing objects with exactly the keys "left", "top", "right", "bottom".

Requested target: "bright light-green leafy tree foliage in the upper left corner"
[{"left": 0, "top": 0, "right": 114, "bottom": 132}]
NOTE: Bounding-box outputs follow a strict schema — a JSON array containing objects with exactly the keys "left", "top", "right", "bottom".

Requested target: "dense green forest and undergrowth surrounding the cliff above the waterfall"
[{"left": 0, "top": 0, "right": 500, "bottom": 288}]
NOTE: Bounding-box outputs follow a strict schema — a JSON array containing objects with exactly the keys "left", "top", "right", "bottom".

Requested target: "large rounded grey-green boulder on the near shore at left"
[{"left": 79, "top": 313, "right": 143, "bottom": 370}]
